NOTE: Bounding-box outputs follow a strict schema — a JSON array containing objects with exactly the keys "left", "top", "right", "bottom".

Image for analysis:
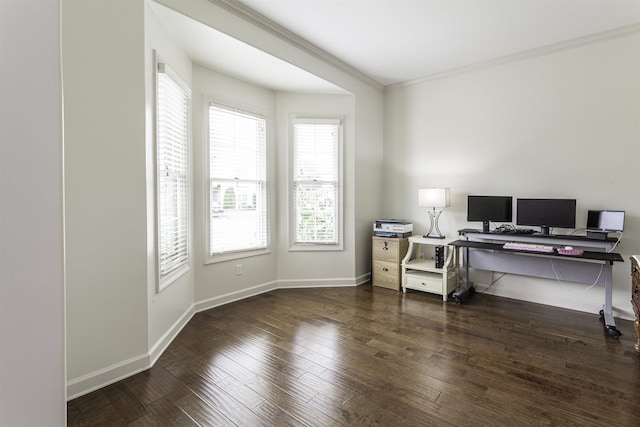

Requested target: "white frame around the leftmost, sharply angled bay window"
[{"left": 154, "top": 56, "right": 193, "bottom": 293}]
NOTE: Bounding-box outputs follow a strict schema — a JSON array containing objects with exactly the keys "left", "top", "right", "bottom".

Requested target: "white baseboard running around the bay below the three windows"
[{"left": 67, "top": 273, "right": 364, "bottom": 400}]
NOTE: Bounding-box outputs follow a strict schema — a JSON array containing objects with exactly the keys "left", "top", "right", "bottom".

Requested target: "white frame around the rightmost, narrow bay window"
[{"left": 288, "top": 115, "right": 344, "bottom": 252}]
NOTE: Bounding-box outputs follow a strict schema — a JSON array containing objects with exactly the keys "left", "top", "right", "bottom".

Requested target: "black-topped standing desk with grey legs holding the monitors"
[{"left": 450, "top": 229, "right": 624, "bottom": 338}]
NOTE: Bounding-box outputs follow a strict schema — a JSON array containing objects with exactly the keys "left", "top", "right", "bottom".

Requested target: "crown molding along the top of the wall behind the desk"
[{"left": 385, "top": 24, "right": 640, "bottom": 89}]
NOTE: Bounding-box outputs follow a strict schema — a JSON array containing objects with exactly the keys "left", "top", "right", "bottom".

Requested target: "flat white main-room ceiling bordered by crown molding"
[{"left": 240, "top": 0, "right": 640, "bottom": 85}]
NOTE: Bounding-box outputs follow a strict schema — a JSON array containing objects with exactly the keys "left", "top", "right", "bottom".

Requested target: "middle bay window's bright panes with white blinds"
[{"left": 208, "top": 103, "right": 268, "bottom": 262}]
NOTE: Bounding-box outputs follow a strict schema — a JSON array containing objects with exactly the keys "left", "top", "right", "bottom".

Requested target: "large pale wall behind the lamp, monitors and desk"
[{"left": 384, "top": 33, "right": 640, "bottom": 318}]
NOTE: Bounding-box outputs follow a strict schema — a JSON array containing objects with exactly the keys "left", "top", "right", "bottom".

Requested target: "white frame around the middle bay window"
[{"left": 203, "top": 100, "right": 271, "bottom": 264}]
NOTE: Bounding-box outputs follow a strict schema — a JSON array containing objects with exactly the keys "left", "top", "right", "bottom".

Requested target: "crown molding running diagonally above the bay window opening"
[{"left": 209, "top": 0, "right": 384, "bottom": 90}]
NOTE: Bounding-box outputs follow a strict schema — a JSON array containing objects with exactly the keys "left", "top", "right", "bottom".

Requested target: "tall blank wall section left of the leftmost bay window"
[{"left": 62, "top": 0, "right": 148, "bottom": 397}]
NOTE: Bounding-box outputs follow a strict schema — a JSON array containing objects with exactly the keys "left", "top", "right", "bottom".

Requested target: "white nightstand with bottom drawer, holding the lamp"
[{"left": 400, "top": 236, "right": 460, "bottom": 301}]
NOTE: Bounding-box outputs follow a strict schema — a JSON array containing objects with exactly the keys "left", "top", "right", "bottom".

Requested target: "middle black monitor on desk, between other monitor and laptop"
[{"left": 516, "top": 199, "right": 576, "bottom": 235}]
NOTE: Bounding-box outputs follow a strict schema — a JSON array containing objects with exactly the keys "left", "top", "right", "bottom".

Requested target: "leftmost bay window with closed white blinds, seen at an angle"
[{"left": 156, "top": 63, "right": 190, "bottom": 290}]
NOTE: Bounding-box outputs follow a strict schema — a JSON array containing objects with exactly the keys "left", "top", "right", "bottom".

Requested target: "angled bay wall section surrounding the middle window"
[{"left": 193, "top": 65, "right": 278, "bottom": 309}]
